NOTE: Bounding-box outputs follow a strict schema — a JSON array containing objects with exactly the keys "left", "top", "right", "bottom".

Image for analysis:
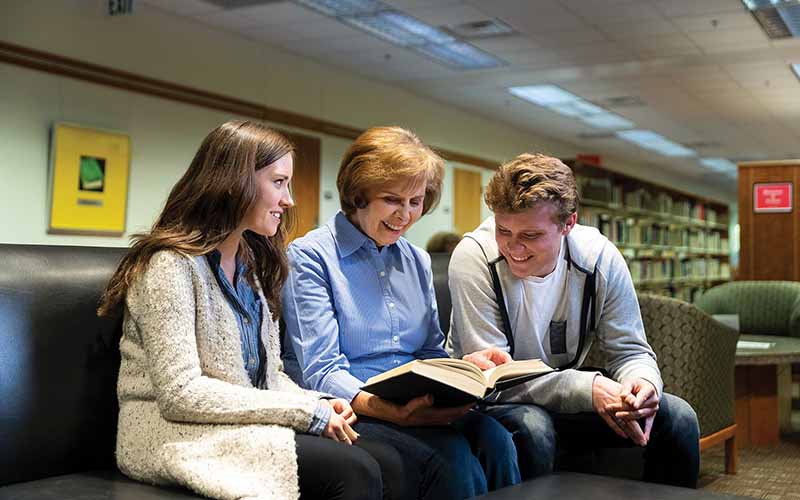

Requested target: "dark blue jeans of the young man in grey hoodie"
[{"left": 481, "top": 394, "right": 700, "bottom": 488}]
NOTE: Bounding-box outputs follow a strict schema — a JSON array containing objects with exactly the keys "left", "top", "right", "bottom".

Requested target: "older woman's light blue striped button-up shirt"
[{"left": 283, "top": 212, "right": 447, "bottom": 401}]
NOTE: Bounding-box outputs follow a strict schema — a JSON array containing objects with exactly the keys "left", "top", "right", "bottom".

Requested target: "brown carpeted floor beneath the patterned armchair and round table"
[{"left": 698, "top": 427, "right": 800, "bottom": 500}]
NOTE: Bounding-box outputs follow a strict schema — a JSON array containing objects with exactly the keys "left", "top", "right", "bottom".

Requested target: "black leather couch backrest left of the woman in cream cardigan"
[{"left": 0, "top": 245, "right": 126, "bottom": 485}]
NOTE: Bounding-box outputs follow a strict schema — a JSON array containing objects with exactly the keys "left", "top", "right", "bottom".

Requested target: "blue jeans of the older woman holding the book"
[{"left": 355, "top": 411, "right": 520, "bottom": 499}]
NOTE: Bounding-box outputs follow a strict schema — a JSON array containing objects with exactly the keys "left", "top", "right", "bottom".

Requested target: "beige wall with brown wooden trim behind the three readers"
[{"left": 0, "top": 0, "right": 731, "bottom": 246}]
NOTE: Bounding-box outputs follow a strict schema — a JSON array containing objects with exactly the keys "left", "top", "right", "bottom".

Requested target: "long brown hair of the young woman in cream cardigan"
[{"left": 97, "top": 121, "right": 294, "bottom": 317}]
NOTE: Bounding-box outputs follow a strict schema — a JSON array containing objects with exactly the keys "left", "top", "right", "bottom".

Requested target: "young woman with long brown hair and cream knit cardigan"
[{"left": 98, "top": 121, "right": 403, "bottom": 500}]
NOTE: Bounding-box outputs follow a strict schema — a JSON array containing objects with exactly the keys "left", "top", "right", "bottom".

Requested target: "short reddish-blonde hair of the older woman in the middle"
[{"left": 336, "top": 127, "right": 444, "bottom": 215}]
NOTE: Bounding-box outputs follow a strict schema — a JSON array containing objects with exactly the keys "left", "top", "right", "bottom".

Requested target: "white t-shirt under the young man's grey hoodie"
[{"left": 509, "top": 238, "right": 567, "bottom": 360}]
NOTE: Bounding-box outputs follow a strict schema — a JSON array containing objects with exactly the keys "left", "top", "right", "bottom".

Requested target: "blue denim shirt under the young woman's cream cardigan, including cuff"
[{"left": 206, "top": 250, "right": 332, "bottom": 434}]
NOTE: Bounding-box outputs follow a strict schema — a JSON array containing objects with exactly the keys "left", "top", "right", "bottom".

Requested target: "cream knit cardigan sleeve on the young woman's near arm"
[{"left": 126, "top": 252, "right": 318, "bottom": 432}]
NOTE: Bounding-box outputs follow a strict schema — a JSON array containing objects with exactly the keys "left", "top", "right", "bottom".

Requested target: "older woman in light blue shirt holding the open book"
[{"left": 283, "top": 127, "right": 519, "bottom": 498}]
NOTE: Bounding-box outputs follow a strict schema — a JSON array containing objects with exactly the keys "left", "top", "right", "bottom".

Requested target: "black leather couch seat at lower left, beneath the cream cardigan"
[{"left": 0, "top": 470, "right": 202, "bottom": 500}]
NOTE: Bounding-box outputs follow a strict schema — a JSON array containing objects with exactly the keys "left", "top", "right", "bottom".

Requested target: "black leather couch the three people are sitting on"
[{"left": 0, "top": 244, "right": 736, "bottom": 500}]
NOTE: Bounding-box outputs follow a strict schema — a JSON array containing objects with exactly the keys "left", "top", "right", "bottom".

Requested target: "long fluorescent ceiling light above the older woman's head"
[{"left": 294, "top": 0, "right": 506, "bottom": 69}]
